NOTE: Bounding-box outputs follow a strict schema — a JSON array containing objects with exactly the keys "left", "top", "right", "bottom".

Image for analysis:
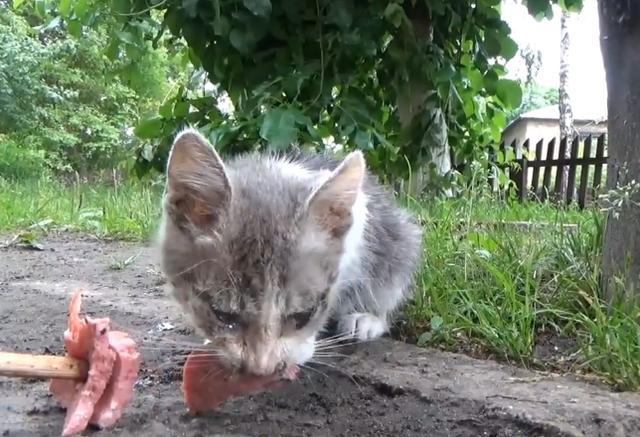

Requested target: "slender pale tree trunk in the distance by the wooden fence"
[{"left": 558, "top": 11, "right": 574, "bottom": 196}]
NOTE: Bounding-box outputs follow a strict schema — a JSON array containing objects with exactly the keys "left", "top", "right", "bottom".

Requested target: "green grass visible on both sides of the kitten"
[{"left": 0, "top": 175, "right": 640, "bottom": 389}]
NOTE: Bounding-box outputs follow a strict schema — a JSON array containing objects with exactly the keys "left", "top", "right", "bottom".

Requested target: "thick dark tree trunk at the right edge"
[{"left": 598, "top": 0, "right": 640, "bottom": 301}]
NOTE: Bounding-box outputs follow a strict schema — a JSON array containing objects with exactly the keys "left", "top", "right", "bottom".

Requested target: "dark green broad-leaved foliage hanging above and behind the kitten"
[{"left": 10, "top": 0, "right": 579, "bottom": 183}]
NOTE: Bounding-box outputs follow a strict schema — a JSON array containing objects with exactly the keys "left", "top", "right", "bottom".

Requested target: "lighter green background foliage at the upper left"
[{"left": 0, "top": 4, "right": 180, "bottom": 174}]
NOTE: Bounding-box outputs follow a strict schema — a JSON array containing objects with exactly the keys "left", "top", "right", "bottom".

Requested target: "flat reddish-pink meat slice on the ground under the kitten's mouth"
[{"left": 182, "top": 350, "right": 298, "bottom": 413}]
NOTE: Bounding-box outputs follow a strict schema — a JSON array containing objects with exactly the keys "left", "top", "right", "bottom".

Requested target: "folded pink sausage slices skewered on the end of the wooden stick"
[{"left": 49, "top": 292, "right": 140, "bottom": 436}]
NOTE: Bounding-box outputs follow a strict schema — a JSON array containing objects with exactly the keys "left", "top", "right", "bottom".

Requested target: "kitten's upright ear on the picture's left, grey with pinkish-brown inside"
[{"left": 167, "top": 129, "right": 231, "bottom": 231}]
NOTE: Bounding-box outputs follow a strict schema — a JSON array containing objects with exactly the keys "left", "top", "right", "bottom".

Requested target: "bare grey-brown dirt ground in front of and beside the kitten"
[{"left": 0, "top": 236, "right": 640, "bottom": 437}]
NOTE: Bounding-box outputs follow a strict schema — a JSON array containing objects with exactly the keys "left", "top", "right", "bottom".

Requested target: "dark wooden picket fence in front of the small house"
[{"left": 500, "top": 134, "right": 607, "bottom": 208}]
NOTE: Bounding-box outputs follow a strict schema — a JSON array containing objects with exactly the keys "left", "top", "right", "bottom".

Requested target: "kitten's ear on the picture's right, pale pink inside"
[{"left": 308, "top": 151, "right": 365, "bottom": 238}]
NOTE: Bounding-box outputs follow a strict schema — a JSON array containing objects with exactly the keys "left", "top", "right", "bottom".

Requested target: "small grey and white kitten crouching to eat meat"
[{"left": 160, "top": 129, "right": 422, "bottom": 375}]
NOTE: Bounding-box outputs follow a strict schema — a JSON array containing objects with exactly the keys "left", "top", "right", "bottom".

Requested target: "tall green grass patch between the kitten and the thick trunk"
[{"left": 399, "top": 195, "right": 640, "bottom": 389}]
